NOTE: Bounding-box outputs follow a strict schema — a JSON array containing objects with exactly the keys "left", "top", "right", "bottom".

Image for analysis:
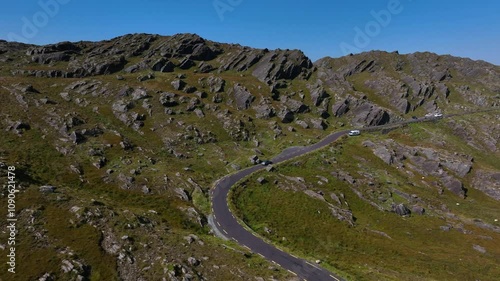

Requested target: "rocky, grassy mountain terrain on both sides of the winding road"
[{"left": 0, "top": 31, "right": 500, "bottom": 281}]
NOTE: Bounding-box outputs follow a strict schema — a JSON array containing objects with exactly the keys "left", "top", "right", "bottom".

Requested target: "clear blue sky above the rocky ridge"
[{"left": 0, "top": 0, "right": 500, "bottom": 65}]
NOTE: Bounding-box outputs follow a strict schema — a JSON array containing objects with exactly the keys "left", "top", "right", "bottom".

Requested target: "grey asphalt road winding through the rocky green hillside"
[{"left": 210, "top": 110, "right": 498, "bottom": 281}]
